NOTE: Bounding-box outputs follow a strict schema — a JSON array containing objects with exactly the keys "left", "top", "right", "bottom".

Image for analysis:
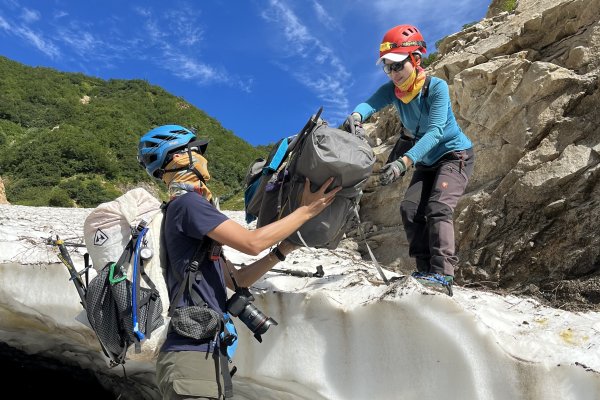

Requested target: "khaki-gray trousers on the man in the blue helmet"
[{"left": 156, "top": 351, "right": 225, "bottom": 400}]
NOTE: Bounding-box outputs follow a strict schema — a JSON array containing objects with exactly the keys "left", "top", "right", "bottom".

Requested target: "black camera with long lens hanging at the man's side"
[{"left": 227, "top": 288, "right": 277, "bottom": 342}]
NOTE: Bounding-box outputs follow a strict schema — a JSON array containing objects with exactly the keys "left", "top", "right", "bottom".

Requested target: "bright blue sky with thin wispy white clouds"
[{"left": 0, "top": 0, "right": 489, "bottom": 145}]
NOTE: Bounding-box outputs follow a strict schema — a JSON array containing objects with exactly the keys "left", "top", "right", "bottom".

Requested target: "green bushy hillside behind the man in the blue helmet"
[{"left": 0, "top": 57, "right": 265, "bottom": 209}]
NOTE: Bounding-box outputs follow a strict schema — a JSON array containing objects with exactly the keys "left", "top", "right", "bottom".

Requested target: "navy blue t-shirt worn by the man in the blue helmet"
[{"left": 161, "top": 192, "right": 228, "bottom": 351}]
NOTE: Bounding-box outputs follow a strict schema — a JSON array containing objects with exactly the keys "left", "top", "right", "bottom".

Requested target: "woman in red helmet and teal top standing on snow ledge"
[{"left": 352, "top": 25, "right": 474, "bottom": 296}]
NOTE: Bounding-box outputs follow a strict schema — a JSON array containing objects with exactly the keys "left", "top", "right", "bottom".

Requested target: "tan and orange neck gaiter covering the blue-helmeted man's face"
[{"left": 162, "top": 151, "right": 212, "bottom": 201}]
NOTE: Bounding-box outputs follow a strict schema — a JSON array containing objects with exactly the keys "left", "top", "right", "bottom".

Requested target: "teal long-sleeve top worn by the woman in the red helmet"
[{"left": 353, "top": 77, "right": 473, "bottom": 165}]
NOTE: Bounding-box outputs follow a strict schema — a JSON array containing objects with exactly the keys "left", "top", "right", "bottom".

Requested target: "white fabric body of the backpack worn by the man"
[{"left": 83, "top": 188, "right": 169, "bottom": 360}]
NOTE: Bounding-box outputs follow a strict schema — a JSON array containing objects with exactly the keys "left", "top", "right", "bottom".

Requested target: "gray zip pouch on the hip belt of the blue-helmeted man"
[{"left": 171, "top": 306, "right": 223, "bottom": 340}]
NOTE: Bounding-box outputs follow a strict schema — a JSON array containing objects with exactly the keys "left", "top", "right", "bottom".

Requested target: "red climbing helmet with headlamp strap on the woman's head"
[{"left": 377, "top": 25, "right": 427, "bottom": 64}]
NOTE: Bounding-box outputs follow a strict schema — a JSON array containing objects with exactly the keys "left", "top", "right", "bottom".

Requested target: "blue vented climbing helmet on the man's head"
[{"left": 138, "top": 125, "right": 206, "bottom": 179}]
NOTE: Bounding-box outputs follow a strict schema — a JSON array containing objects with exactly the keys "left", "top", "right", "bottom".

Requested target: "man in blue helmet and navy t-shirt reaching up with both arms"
[{"left": 138, "top": 125, "right": 341, "bottom": 400}]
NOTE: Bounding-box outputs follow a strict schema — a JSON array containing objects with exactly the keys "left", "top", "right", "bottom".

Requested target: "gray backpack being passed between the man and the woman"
[{"left": 246, "top": 108, "right": 375, "bottom": 249}]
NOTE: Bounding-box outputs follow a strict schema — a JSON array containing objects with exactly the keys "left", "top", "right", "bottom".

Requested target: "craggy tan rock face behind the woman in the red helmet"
[{"left": 361, "top": 0, "right": 600, "bottom": 306}]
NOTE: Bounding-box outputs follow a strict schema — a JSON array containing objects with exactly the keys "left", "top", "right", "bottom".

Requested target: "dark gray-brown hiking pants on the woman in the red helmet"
[{"left": 400, "top": 149, "right": 475, "bottom": 276}]
